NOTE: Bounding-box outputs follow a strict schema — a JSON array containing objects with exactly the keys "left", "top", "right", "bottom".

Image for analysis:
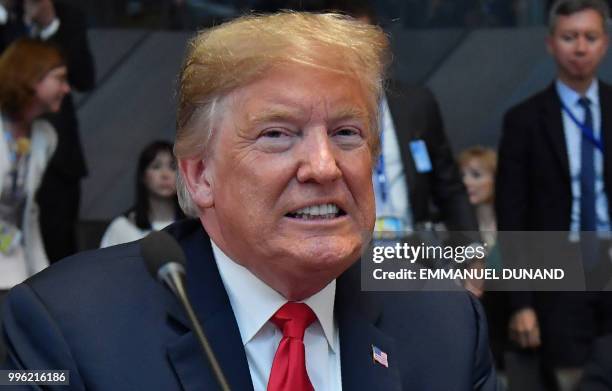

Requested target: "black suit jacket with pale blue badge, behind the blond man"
[{"left": 387, "top": 84, "right": 478, "bottom": 231}]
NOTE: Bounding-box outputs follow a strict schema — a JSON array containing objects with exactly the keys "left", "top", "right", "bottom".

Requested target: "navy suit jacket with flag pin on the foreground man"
[{"left": 4, "top": 220, "right": 495, "bottom": 391}]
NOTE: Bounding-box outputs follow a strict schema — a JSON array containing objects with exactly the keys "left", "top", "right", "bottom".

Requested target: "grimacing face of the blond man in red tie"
[{"left": 192, "top": 65, "right": 375, "bottom": 299}]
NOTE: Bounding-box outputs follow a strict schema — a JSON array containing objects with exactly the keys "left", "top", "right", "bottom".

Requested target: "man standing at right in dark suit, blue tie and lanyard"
[{"left": 495, "top": 0, "right": 612, "bottom": 386}]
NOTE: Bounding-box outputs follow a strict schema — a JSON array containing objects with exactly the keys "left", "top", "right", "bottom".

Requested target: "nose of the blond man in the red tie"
[{"left": 297, "top": 130, "right": 342, "bottom": 183}]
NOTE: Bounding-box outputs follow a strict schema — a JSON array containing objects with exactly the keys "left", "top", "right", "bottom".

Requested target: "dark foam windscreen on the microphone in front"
[{"left": 140, "top": 231, "right": 185, "bottom": 279}]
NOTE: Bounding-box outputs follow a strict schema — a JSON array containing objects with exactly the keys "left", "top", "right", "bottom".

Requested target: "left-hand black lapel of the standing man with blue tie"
[{"left": 542, "top": 83, "right": 570, "bottom": 181}]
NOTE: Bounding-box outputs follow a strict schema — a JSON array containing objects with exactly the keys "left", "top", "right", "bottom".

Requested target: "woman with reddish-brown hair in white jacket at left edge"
[{"left": 0, "top": 39, "right": 70, "bottom": 294}]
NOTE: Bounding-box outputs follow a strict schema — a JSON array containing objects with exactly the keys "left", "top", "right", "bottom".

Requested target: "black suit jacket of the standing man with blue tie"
[{"left": 495, "top": 82, "right": 612, "bottom": 366}]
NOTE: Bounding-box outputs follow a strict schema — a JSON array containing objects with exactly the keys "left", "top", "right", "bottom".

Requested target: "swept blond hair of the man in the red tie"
[{"left": 174, "top": 11, "right": 390, "bottom": 215}]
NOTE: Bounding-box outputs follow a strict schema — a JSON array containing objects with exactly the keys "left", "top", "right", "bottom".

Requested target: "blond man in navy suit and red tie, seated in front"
[{"left": 4, "top": 13, "right": 495, "bottom": 391}]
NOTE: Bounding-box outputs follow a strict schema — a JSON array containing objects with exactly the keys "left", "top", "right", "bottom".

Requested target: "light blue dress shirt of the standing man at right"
[{"left": 556, "top": 80, "right": 610, "bottom": 240}]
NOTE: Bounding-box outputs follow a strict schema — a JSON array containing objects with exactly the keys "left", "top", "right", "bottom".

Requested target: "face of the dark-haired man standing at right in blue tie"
[{"left": 547, "top": 9, "right": 608, "bottom": 83}]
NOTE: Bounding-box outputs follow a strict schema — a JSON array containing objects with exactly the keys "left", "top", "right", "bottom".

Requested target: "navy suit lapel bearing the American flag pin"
[{"left": 335, "top": 265, "right": 402, "bottom": 390}]
